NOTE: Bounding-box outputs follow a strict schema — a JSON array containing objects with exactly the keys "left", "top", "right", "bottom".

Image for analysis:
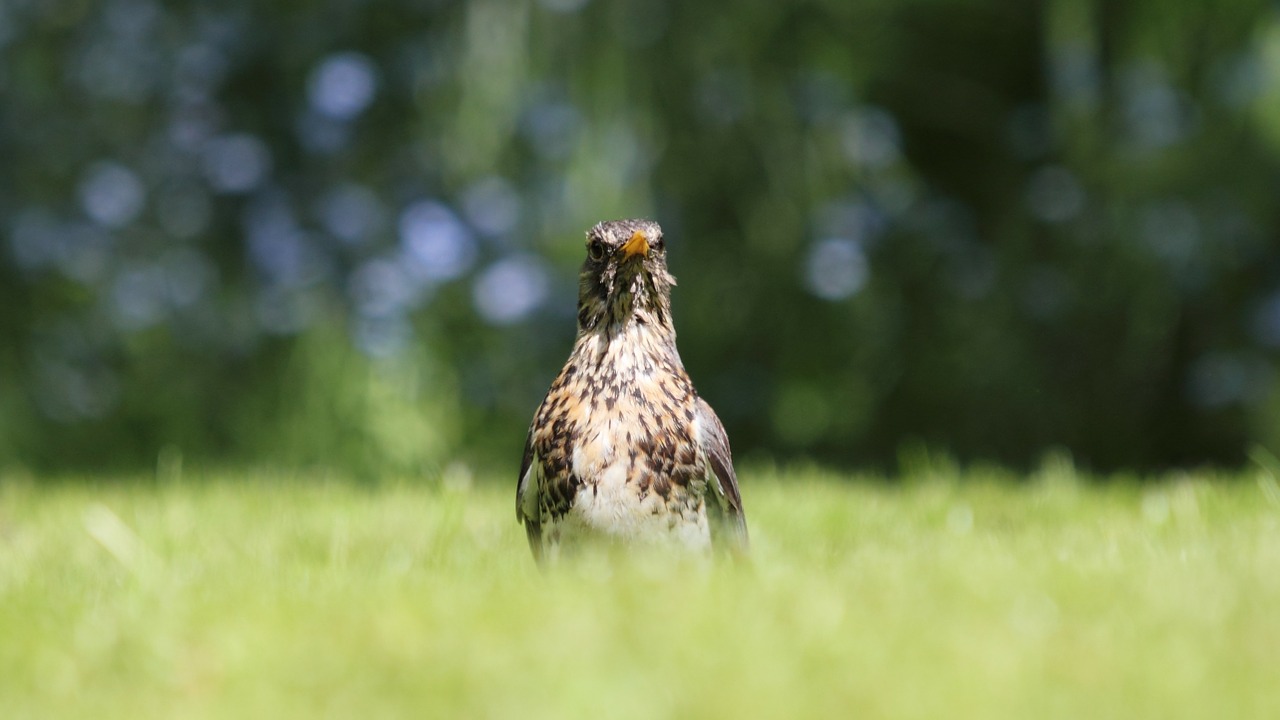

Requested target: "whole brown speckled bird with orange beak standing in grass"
[{"left": 516, "top": 219, "right": 749, "bottom": 565}]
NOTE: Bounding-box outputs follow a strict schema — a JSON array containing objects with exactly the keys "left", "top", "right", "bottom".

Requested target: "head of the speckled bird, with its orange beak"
[{"left": 577, "top": 220, "right": 676, "bottom": 332}]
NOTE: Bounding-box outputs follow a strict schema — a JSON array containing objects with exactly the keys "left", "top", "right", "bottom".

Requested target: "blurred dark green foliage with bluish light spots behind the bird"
[{"left": 0, "top": 0, "right": 1280, "bottom": 478}]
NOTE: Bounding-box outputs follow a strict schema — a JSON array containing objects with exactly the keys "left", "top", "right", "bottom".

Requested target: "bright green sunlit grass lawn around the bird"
[{"left": 0, "top": 462, "right": 1280, "bottom": 719}]
